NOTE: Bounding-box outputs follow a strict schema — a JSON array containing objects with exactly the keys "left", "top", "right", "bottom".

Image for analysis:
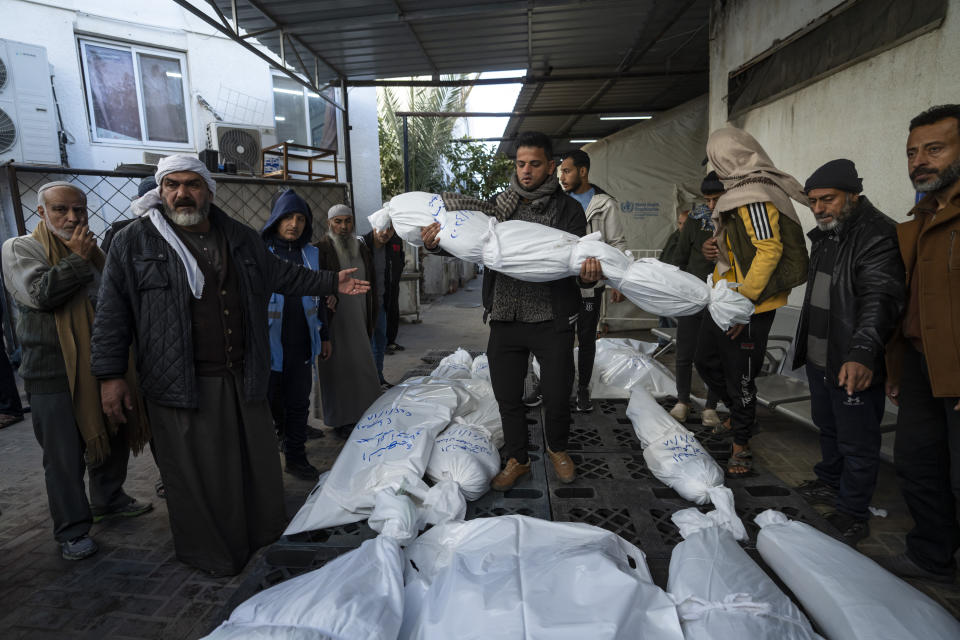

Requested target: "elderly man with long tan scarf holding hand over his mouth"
[{"left": 3, "top": 182, "right": 151, "bottom": 560}]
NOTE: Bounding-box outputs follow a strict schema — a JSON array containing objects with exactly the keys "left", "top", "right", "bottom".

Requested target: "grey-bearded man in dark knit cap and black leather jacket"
[{"left": 793, "top": 159, "right": 906, "bottom": 545}]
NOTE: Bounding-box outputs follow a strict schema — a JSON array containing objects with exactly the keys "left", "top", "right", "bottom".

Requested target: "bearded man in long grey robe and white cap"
[{"left": 316, "top": 204, "right": 381, "bottom": 438}]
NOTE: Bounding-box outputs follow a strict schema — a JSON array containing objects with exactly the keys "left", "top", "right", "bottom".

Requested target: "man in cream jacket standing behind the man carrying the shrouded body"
[{"left": 560, "top": 149, "right": 627, "bottom": 413}]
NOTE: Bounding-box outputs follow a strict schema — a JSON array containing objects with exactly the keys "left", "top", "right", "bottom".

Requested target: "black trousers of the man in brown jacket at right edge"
[{"left": 893, "top": 346, "right": 960, "bottom": 573}]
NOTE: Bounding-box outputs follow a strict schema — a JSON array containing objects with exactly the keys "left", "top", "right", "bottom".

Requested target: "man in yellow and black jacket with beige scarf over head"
[{"left": 696, "top": 128, "right": 808, "bottom": 477}]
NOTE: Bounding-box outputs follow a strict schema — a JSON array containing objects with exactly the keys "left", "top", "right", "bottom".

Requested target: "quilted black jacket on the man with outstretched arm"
[{"left": 91, "top": 207, "right": 337, "bottom": 408}]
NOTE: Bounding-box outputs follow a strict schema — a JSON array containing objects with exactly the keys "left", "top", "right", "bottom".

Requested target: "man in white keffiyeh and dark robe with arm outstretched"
[{"left": 91, "top": 155, "right": 369, "bottom": 575}]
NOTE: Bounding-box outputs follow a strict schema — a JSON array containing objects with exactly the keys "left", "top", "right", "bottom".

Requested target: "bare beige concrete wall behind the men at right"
[{"left": 710, "top": 0, "right": 960, "bottom": 225}]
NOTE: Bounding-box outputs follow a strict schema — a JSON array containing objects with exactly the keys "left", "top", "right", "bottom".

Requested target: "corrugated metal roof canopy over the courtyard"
[{"left": 201, "top": 0, "right": 710, "bottom": 152}]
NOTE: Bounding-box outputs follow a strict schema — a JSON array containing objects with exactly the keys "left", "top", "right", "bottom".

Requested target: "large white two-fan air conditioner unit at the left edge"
[{"left": 0, "top": 39, "right": 60, "bottom": 165}]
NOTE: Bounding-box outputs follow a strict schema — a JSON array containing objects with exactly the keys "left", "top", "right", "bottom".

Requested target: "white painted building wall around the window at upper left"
[{"left": 0, "top": 0, "right": 381, "bottom": 226}]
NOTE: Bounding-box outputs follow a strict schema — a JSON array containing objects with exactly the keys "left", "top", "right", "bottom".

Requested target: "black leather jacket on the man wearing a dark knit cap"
[{"left": 793, "top": 196, "right": 906, "bottom": 385}]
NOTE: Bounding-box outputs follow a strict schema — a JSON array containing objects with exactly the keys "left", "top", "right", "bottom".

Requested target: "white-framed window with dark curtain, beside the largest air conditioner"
[{"left": 80, "top": 38, "right": 191, "bottom": 147}]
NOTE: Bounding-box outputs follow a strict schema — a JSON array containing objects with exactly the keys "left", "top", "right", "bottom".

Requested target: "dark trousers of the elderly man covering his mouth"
[{"left": 30, "top": 391, "right": 131, "bottom": 542}]
